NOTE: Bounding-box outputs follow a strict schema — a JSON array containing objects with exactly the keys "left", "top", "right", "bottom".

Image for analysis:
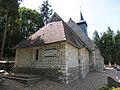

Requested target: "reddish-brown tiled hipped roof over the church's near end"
[{"left": 16, "top": 20, "right": 84, "bottom": 48}]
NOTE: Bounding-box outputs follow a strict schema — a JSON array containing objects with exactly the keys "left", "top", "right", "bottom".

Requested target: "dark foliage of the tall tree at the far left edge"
[{"left": 0, "top": 0, "right": 21, "bottom": 58}]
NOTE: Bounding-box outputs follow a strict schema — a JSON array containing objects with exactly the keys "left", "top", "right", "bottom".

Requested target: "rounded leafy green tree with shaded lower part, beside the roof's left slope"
[{"left": 0, "top": 7, "right": 44, "bottom": 57}]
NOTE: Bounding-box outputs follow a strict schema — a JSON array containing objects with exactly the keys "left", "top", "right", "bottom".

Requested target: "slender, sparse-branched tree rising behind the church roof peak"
[{"left": 39, "top": 0, "right": 53, "bottom": 24}]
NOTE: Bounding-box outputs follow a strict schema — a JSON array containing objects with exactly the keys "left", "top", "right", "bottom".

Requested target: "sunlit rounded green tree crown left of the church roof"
[{"left": 18, "top": 7, "right": 44, "bottom": 40}]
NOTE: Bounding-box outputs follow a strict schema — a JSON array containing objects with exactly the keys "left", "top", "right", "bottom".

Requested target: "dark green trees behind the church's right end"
[{"left": 93, "top": 27, "right": 120, "bottom": 64}]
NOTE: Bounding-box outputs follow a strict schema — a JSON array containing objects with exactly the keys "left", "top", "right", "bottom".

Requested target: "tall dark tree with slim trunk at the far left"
[{"left": 0, "top": 0, "right": 21, "bottom": 59}]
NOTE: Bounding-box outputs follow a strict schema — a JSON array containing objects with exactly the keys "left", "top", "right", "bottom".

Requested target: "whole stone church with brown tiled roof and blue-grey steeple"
[{"left": 14, "top": 12, "right": 104, "bottom": 84}]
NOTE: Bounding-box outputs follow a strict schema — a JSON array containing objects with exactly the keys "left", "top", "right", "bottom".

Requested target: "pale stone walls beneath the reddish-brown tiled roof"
[{"left": 14, "top": 42, "right": 89, "bottom": 83}]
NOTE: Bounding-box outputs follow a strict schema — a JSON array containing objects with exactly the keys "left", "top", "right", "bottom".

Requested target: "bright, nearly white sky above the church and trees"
[{"left": 20, "top": 0, "right": 120, "bottom": 39}]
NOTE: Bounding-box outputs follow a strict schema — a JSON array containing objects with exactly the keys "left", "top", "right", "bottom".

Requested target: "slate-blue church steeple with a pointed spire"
[{"left": 77, "top": 11, "right": 88, "bottom": 36}]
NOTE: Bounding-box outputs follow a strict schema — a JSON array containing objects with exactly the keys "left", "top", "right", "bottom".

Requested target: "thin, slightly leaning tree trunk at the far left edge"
[{"left": 0, "top": 13, "right": 8, "bottom": 60}]
